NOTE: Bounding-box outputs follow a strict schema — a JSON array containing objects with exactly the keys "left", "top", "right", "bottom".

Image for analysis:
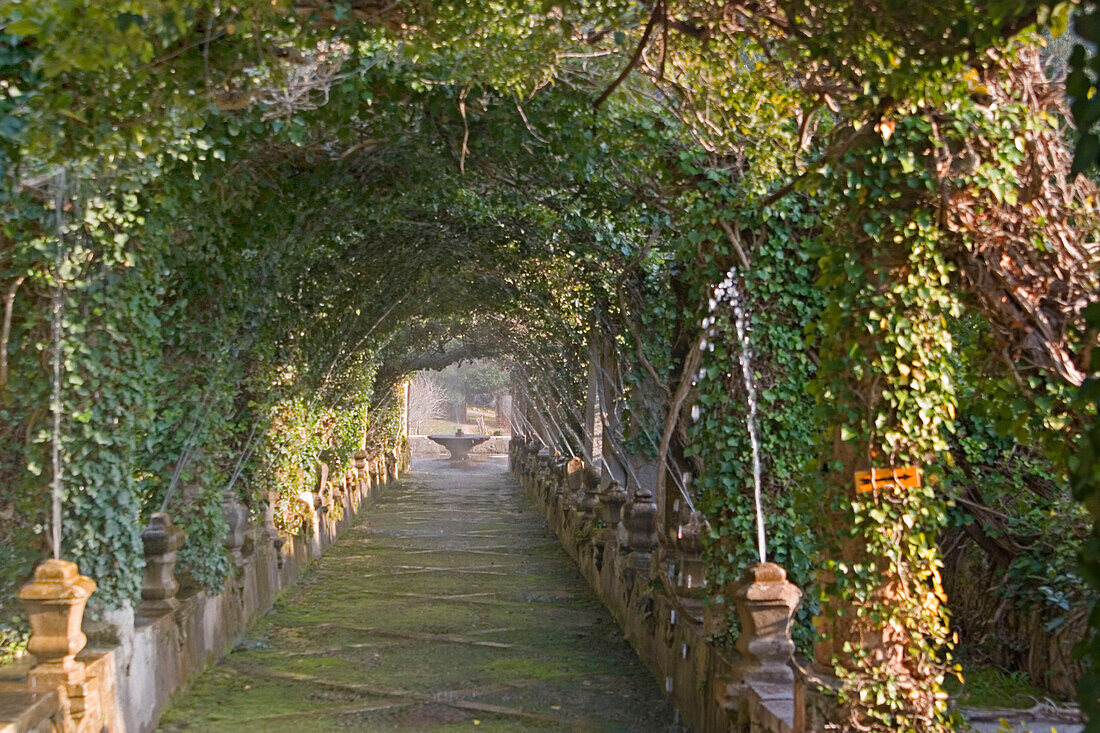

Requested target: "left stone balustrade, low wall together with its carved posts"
[{"left": 0, "top": 455, "right": 408, "bottom": 733}]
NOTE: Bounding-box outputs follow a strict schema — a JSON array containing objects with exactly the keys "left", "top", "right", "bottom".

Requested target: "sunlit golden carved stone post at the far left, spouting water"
[{"left": 19, "top": 559, "right": 96, "bottom": 730}]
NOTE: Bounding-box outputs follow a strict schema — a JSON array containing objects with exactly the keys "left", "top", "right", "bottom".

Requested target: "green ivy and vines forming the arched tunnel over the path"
[{"left": 0, "top": 0, "right": 1096, "bottom": 730}]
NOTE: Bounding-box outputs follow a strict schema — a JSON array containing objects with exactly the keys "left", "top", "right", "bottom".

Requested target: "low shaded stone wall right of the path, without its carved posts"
[{"left": 509, "top": 437, "right": 794, "bottom": 733}]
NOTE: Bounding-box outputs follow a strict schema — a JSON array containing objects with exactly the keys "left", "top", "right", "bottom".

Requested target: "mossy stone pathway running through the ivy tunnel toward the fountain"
[{"left": 161, "top": 459, "right": 678, "bottom": 733}]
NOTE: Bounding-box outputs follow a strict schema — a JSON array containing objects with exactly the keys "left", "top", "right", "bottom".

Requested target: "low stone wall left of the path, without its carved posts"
[{"left": 0, "top": 453, "right": 408, "bottom": 733}]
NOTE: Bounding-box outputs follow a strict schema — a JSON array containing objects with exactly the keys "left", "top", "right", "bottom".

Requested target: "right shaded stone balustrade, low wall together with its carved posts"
[{"left": 508, "top": 435, "right": 810, "bottom": 733}]
